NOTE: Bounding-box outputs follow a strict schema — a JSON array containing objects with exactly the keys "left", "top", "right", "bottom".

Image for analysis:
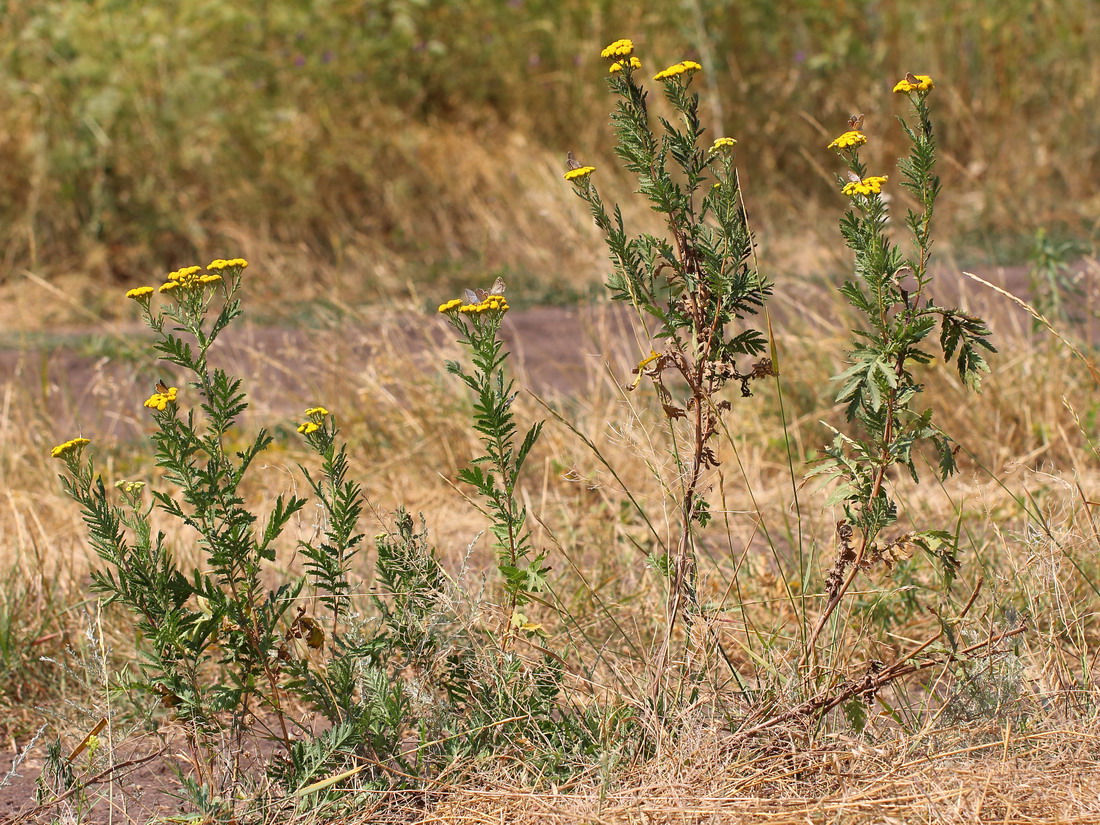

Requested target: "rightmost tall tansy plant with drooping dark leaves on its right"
[{"left": 807, "top": 74, "right": 993, "bottom": 651}]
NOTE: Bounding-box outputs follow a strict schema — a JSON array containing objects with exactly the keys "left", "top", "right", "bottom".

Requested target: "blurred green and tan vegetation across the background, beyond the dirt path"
[{"left": 0, "top": 0, "right": 1100, "bottom": 294}]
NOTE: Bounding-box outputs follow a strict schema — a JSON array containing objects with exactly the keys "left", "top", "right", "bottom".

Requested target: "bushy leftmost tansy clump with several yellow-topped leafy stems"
[{"left": 53, "top": 259, "right": 424, "bottom": 800}]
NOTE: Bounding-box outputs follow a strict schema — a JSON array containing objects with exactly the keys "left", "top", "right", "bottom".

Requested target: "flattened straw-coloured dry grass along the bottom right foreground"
[{"left": 411, "top": 726, "right": 1100, "bottom": 825}]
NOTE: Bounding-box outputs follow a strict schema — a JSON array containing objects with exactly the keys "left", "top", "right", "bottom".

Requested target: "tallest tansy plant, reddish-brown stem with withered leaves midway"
[{"left": 565, "top": 40, "right": 773, "bottom": 699}]
